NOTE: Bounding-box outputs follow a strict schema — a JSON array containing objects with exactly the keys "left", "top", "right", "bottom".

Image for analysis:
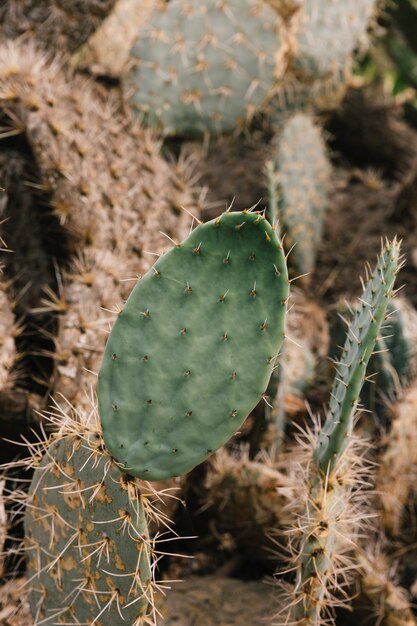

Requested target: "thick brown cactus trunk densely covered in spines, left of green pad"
[{"left": 0, "top": 41, "right": 191, "bottom": 416}]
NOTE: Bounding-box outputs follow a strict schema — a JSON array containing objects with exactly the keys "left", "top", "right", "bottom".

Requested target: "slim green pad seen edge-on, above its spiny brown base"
[{"left": 314, "top": 239, "right": 401, "bottom": 474}]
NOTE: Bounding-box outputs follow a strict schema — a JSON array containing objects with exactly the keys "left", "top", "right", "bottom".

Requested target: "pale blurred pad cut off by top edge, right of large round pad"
[{"left": 294, "top": 0, "right": 375, "bottom": 80}]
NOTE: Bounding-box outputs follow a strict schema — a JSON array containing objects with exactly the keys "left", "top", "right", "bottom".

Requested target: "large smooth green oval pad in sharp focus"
[{"left": 98, "top": 211, "right": 288, "bottom": 480}]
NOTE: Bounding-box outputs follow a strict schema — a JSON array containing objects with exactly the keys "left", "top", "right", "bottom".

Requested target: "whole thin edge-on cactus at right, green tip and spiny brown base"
[{"left": 279, "top": 240, "right": 400, "bottom": 626}]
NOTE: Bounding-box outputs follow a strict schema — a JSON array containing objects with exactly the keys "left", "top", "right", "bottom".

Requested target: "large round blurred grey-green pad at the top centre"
[{"left": 125, "top": 0, "right": 288, "bottom": 136}]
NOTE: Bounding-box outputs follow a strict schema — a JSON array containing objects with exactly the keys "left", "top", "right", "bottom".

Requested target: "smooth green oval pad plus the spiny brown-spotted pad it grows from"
[{"left": 3, "top": 211, "right": 288, "bottom": 626}]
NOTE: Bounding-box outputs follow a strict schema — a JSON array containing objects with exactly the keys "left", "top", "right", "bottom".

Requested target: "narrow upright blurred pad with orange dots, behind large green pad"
[{"left": 275, "top": 113, "right": 330, "bottom": 274}]
